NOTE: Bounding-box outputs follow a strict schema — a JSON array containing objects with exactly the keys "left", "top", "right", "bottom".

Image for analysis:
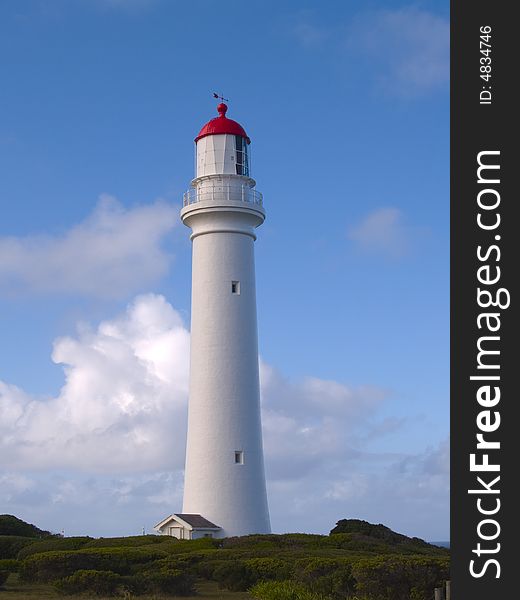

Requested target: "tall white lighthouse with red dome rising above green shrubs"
[{"left": 180, "top": 104, "right": 270, "bottom": 536}]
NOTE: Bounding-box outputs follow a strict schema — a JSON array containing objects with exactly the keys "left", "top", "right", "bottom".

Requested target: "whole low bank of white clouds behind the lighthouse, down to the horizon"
[{"left": 0, "top": 294, "right": 448, "bottom": 538}]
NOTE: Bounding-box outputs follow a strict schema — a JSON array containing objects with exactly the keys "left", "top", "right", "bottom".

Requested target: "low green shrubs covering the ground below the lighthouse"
[{"left": 0, "top": 520, "right": 449, "bottom": 600}]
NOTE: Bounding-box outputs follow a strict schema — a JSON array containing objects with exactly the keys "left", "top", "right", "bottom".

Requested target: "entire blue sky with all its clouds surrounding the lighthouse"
[{"left": 0, "top": 0, "right": 449, "bottom": 540}]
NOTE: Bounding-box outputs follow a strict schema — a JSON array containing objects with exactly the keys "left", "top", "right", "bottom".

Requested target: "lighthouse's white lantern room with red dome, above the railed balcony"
[{"left": 195, "top": 103, "right": 251, "bottom": 177}]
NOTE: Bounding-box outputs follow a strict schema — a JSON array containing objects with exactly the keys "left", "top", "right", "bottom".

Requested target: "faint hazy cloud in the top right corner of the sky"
[{"left": 290, "top": 6, "right": 450, "bottom": 97}]
